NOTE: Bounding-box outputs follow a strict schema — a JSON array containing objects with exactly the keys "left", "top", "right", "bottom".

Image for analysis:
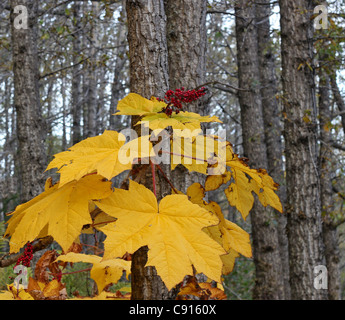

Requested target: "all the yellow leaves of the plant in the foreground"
[{"left": 3, "top": 93, "right": 282, "bottom": 299}]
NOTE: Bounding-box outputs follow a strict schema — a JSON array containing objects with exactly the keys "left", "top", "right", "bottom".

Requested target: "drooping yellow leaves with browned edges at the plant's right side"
[{"left": 172, "top": 136, "right": 283, "bottom": 219}]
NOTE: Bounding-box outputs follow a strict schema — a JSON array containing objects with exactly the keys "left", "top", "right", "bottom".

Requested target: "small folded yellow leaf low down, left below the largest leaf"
[{"left": 57, "top": 252, "right": 131, "bottom": 292}]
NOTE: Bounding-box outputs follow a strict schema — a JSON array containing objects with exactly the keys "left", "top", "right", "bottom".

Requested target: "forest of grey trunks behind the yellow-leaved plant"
[{"left": 0, "top": 0, "right": 345, "bottom": 299}]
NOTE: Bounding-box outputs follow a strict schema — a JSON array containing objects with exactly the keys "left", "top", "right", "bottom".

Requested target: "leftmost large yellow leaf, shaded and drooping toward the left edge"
[{"left": 6, "top": 174, "right": 112, "bottom": 252}]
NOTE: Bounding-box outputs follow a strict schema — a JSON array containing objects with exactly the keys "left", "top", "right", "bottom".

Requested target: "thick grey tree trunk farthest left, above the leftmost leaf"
[{"left": 10, "top": 0, "right": 47, "bottom": 202}]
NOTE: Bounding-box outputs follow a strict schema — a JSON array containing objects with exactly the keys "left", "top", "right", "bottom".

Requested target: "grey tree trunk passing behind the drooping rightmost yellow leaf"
[{"left": 235, "top": 0, "right": 284, "bottom": 300}]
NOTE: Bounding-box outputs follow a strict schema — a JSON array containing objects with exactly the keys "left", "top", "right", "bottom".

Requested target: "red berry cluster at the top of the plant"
[{"left": 159, "top": 87, "right": 206, "bottom": 116}]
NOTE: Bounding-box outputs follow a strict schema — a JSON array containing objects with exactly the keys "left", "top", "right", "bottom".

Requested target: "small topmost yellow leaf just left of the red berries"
[{"left": 115, "top": 93, "right": 167, "bottom": 116}]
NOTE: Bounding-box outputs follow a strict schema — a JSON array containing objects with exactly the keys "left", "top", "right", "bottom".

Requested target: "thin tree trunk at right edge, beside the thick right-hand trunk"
[{"left": 319, "top": 71, "right": 340, "bottom": 300}]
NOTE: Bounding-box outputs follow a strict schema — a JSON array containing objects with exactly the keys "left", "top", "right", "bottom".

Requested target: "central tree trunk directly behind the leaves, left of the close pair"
[{"left": 126, "top": 0, "right": 170, "bottom": 300}]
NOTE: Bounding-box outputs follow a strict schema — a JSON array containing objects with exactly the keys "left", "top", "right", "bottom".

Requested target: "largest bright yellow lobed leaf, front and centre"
[{"left": 97, "top": 181, "right": 225, "bottom": 289}]
